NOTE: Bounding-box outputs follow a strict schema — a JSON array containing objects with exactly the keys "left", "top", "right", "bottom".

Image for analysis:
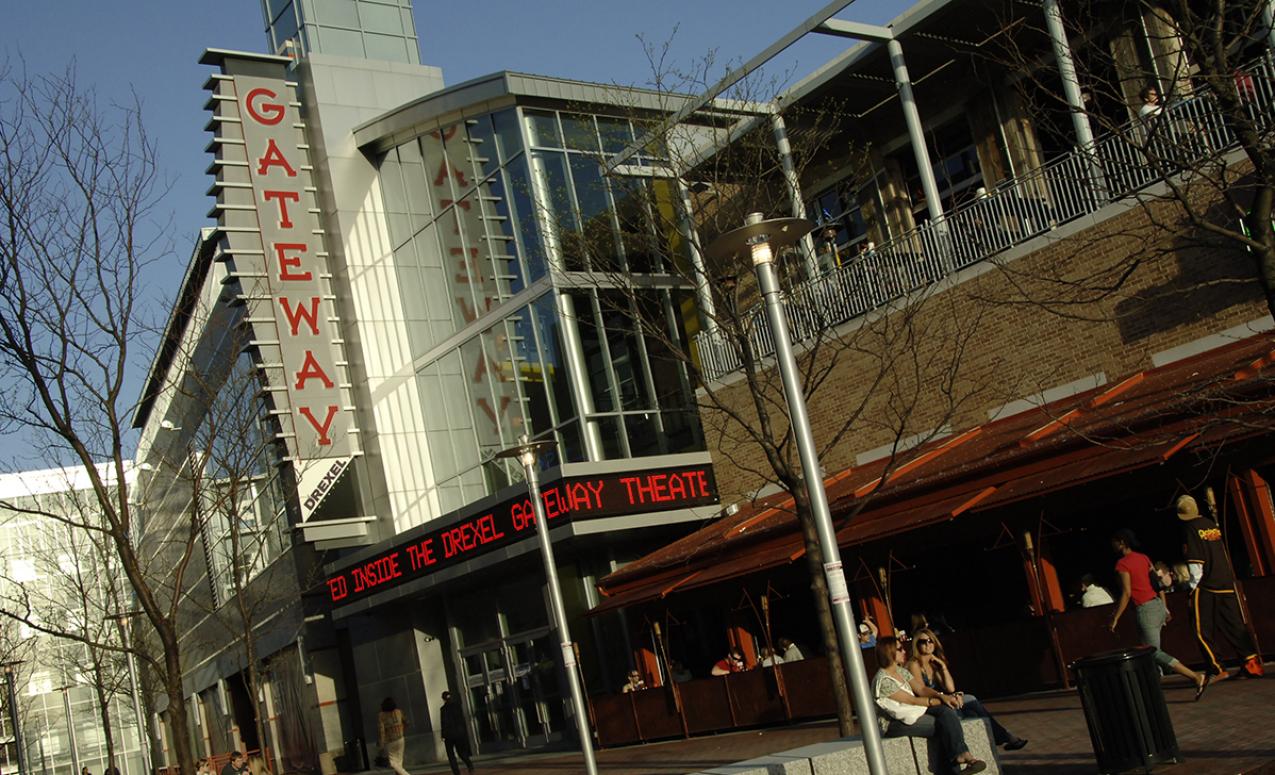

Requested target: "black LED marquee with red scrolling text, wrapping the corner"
[{"left": 328, "top": 464, "right": 718, "bottom": 605}]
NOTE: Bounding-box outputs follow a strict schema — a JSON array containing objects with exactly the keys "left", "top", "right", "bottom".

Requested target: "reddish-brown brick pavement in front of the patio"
[{"left": 412, "top": 665, "right": 1275, "bottom": 775}]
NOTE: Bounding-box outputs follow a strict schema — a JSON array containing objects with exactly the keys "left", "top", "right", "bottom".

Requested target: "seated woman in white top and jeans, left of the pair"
[{"left": 872, "top": 635, "right": 987, "bottom": 775}]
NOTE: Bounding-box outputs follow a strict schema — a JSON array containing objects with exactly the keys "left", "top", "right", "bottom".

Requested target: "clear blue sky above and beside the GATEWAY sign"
[{"left": 0, "top": 0, "right": 907, "bottom": 470}]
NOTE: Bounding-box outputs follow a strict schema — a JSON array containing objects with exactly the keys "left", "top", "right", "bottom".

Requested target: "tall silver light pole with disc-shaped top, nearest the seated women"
[{"left": 705, "top": 213, "right": 889, "bottom": 775}]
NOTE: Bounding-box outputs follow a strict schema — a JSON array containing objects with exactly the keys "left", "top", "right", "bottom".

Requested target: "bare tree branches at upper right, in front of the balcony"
[{"left": 988, "top": 0, "right": 1275, "bottom": 316}]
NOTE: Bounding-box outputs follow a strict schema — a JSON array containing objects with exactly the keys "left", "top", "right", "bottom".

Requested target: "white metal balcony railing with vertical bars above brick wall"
[{"left": 695, "top": 54, "right": 1275, "bottom": 380}]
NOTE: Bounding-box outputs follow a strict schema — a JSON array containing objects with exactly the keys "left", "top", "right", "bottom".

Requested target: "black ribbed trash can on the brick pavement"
[{"left": 1071, "top": 646, "right": 1181, "bottom": 772}]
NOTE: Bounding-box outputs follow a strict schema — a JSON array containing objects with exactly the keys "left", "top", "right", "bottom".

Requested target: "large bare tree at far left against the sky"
[{"left": 0, "top": 69, "right": 198, "bottom": 771}]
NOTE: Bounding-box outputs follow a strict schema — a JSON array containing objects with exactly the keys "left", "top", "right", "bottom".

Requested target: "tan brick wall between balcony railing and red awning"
[{"left": 700, "top": 191, "right": 1267, "bottom": 502}]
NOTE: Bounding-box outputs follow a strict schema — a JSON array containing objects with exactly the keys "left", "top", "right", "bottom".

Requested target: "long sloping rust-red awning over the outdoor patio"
[{"left": 593, "top": 335, "right": 1275, "bottom": 613}]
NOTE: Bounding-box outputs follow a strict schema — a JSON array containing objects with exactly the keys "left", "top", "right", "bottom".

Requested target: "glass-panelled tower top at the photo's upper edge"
[{"left": 261, "top": 0, "right": 421, "bottom": 64}]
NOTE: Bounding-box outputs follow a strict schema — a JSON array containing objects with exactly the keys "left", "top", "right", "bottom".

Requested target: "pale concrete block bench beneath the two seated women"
[{"left": 695, "top": 719, "right": 1001, "bottom": 775}]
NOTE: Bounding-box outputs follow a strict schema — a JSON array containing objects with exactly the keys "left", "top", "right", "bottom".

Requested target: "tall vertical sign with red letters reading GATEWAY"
[{"left": 200, "top": 50, "right": 358, "bottom": 521}]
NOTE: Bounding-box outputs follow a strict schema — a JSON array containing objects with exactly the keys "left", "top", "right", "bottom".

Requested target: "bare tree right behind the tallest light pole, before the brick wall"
[{"left": 547, "top": 47, "right": 980, "bottom": 734}]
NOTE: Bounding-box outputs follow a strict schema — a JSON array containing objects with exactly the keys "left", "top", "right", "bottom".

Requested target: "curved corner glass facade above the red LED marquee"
[{"left": 380, "top": 108, "right": 703, "bottom": 512}]
